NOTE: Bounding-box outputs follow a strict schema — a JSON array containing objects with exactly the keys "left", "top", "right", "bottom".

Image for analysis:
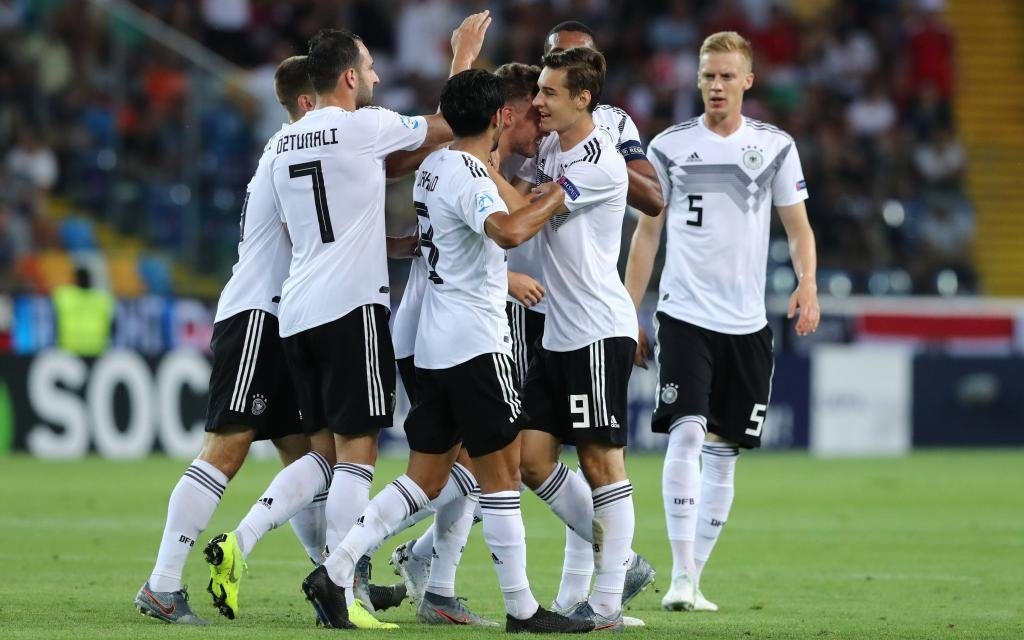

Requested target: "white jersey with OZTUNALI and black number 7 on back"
[{"left": 270, "top": 106, "right": 427, "bottom": 337}]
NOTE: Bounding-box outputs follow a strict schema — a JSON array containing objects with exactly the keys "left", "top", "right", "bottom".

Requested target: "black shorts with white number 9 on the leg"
[{"left": 523, "top": 337, "right": 637, "bottom": 446}]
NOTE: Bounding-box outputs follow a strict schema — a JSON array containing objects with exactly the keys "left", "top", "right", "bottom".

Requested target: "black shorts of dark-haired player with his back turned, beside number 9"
[{"left": 406, "top": 353, "right": 526, "bottom": 458}]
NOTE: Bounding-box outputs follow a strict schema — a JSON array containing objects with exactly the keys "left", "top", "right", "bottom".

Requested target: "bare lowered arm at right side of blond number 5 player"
[{"left": 776, "top": 201, "right": 821, "bottom": 336}]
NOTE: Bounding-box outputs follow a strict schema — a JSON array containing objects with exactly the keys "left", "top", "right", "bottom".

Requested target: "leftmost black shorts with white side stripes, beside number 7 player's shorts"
[{"left": 206, "top": 309, "right": 303, "bottom": 440}]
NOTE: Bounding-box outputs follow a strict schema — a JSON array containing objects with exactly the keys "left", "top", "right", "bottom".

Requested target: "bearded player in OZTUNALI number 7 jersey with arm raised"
[{"left": 201, "top": 18, "right": 489, "bottom": 626}]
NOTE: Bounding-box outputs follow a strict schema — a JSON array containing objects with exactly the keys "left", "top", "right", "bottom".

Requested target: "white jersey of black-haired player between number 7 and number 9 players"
[{"left": 413, "top": 148, "right": 512, "bottom": 369}]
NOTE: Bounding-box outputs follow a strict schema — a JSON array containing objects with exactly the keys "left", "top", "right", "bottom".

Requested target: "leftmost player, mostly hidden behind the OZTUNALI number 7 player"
[{"left": 135, "top": 55, "right": 327, "bottom": 625}]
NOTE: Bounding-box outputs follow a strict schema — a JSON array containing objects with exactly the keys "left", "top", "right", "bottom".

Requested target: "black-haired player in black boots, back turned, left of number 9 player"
[{"left": 303, "top": 70, "right": 593, "bottom": 633}]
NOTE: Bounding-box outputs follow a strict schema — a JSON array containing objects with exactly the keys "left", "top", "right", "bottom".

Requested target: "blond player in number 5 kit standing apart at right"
[{"left": 626, "top": 32, "right": 819, "bottom": 611}]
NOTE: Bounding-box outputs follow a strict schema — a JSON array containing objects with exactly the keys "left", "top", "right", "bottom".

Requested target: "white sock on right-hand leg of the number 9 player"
[{"left": 590, "top": 480, "right": 636, "bottom": 617}]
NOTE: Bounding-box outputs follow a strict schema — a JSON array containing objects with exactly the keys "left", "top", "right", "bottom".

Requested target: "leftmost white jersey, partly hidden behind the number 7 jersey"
[{"left": 214, "top": 125, "right": 292, "bottom": 323}]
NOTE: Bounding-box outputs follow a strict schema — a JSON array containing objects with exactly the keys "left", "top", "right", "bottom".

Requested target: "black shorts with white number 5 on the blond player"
[{"left": 651, "top": 312, "right": 775, "bottom": 449}]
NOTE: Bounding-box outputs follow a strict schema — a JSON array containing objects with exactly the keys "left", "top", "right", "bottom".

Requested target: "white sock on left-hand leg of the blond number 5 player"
[{"left": 662, "top": 416, "right": 708, "bottom": 578}]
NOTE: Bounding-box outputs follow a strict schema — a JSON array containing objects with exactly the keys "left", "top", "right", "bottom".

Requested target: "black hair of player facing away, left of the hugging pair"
[{"left": 441, "top": 69, "right": 505, "bottom": 137}]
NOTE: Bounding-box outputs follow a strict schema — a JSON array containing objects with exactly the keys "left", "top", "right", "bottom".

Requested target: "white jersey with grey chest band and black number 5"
[{"left": 647, "top": 116, "right": 807, "bottom": 335}]
